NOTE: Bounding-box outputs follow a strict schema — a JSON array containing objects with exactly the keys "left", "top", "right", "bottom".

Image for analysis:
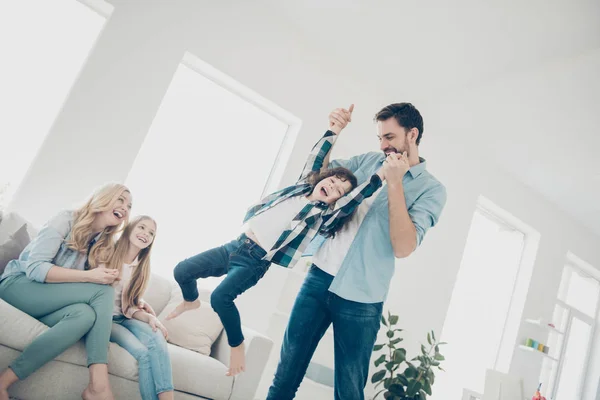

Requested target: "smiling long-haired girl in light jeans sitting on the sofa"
[{"left": 108, "top": 215, "right": 173, "bottom": 400}]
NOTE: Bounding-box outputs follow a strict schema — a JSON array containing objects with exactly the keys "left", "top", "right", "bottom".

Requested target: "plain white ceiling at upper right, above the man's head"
[{"left": 264, "top": 0, "right": 600, "bottom": 235}]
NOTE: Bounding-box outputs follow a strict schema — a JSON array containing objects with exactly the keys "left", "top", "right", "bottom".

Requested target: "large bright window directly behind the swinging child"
[{"left": 126, "top": 54, "right": 299, "bottom": 285}]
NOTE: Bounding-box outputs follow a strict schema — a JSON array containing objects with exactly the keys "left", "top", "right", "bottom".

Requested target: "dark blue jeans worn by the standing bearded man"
[{"left": 267, "top": 265, "right": 383, "bottom": 400}]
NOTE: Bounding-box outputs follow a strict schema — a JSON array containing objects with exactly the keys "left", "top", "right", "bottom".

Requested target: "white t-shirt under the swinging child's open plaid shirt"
[{"left": 247, "top": 196, "right": 308, "bottom": 251}]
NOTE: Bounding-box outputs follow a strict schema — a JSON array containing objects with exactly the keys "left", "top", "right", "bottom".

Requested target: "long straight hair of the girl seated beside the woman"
[{"left": 108, "top": 215, "right": 156, "bottom": 308}]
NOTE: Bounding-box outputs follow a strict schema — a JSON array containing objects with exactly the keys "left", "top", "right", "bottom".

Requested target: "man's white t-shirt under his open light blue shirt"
[{"left": 313, "top": 181, "right": 385, "bottom": 276}]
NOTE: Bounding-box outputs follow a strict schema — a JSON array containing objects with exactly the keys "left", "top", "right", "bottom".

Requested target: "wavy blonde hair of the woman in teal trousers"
[{"left": 67, "top": 183, "right": 129, "bottom": 268}]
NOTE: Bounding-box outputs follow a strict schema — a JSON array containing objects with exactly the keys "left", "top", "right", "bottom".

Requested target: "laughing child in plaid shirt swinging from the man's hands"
[{"left": 167, "top": 131, "right": 382, "bottom": 375}]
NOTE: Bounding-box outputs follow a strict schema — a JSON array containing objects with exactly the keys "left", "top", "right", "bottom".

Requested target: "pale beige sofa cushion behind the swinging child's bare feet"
[{"left": 158, "top": 285, "right": 223, "bottom": 356}]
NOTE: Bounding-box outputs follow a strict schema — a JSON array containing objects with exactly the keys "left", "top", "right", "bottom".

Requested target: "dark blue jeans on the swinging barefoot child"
[{"left": 173, "top": 235, "right": 271, "bottom": 347}]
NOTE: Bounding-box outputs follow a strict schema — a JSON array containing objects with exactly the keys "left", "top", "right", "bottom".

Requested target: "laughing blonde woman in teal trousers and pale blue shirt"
[{"left": 0, "top": 184, "right": 131, "bottom": 400}]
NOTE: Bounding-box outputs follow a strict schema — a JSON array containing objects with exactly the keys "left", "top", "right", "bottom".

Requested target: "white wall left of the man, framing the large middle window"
[{"left": 8, "top": 0, "right": 378, "bottom": 227}]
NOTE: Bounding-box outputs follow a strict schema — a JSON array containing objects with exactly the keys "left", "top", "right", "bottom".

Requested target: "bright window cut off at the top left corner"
[{"left": 0, "top": 0, "right": 112, "bottom": 207}]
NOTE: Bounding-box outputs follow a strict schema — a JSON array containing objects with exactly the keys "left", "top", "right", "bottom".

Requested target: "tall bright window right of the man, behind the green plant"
[{"left": 436, "top": 198, "right": 538, "bottom": 399}]
